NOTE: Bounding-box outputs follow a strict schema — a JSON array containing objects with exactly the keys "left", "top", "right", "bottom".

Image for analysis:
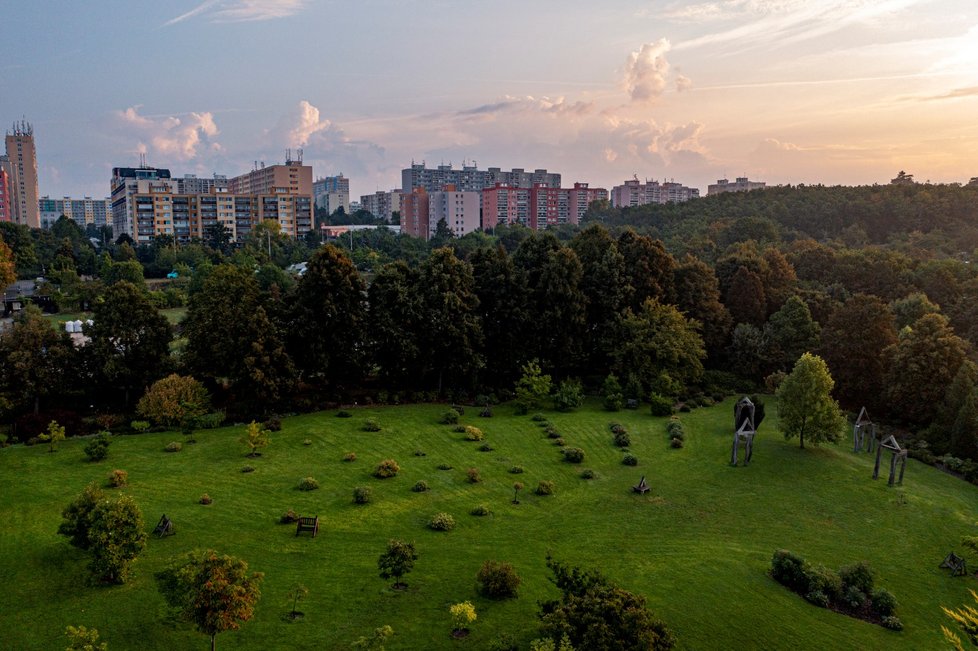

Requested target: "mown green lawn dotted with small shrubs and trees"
[{"left": 0, "top": 399, "right": 978, "bottom": 651}]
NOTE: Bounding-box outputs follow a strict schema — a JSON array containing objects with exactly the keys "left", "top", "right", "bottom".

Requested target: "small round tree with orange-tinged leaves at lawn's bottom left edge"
[{"left": 156, "top": 549, "right": 264, "bottom": 651}]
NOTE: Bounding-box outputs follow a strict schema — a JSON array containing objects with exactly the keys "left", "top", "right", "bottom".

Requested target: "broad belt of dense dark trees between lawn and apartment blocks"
[{"left": 0, "top": 183, "right": 978, "bottom": 479}]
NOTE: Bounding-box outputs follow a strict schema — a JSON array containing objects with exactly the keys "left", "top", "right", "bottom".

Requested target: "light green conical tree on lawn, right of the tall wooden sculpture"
[{"left": 778, "top": 353, "right": 846, "bottom": 449}]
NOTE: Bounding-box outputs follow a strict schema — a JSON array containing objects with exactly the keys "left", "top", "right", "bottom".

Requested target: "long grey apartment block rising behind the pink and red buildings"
[{"left": 401, "top": 163, "right": 560, "bottom": 193}]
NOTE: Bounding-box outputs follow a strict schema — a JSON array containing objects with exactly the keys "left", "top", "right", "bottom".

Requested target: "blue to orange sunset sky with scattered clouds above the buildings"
[{"left": 0, "top": 0, "right": 978, "bottom": 199}]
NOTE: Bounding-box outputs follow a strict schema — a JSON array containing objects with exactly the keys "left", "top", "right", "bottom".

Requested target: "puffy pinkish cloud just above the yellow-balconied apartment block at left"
[{"left": 114, "top": 106, "right": 221, "bottom": 161}]
